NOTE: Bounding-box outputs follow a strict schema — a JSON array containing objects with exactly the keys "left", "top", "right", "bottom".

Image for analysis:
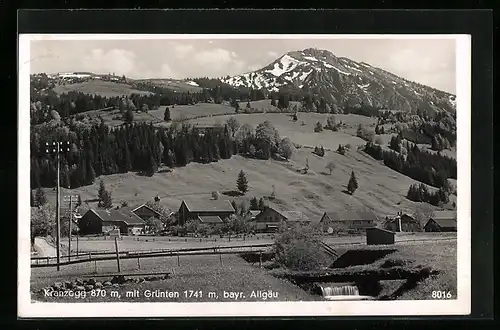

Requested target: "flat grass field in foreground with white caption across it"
[{"left": 31, "top": 255, "right": 314, "bottom": 302}]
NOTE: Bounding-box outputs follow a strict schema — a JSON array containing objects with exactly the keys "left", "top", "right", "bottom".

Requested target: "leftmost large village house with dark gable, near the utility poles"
[{"left": 78, "top": 209, "right": 145, "bottom": 235}]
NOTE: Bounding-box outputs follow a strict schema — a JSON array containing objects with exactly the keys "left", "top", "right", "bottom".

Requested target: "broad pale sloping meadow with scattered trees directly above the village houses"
[{"left": 38, "top": 145, "right": 455, "bottom": 221}]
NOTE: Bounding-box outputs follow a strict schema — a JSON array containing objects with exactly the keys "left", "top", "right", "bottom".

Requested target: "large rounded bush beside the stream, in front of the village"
[{"left": 274, "top": 227, "right": 329, "bottom": 271}]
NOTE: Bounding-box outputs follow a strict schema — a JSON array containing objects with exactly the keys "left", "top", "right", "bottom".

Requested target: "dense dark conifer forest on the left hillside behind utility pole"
[{"left": 31, "top": 122, "right": 234, "bottom": 188}]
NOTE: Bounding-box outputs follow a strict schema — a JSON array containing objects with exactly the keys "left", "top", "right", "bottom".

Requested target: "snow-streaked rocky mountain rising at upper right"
[{"left": 220, "top": 48, "right": 456, "bottom": 112}]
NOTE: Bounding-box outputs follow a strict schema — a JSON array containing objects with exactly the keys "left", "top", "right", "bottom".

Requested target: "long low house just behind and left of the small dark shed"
[{"left": 320, "top": 211, "right": 378, "bottom": 233}]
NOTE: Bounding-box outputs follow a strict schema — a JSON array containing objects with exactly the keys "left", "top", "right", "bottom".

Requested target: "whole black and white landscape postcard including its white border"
[{"left": 18, "top": 34, "right": 470, "bottom": 316}]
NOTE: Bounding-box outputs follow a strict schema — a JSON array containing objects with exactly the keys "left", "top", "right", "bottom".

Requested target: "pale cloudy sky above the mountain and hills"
[{"left": 30, "top": 38, "right": 456, "bottom": 94}]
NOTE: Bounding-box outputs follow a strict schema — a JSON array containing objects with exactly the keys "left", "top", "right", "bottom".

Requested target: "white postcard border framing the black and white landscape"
[{"left": 18, "top": 34, "right": 471, "bottom": 318}]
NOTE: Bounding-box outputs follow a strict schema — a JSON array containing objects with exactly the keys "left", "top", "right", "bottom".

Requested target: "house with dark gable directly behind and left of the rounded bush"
[{"left": 254, "top": 207, "right": 311, "bottom": 232}]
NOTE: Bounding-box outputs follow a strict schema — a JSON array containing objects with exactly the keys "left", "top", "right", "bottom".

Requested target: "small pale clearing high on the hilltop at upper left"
[{"left": 54, "top": 80, "right": 151, "bottom": 97}]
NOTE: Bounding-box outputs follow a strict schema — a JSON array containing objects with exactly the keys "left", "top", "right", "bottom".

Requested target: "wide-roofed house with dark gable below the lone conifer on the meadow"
[{"left": 177, "top": 200, "right": 236, "bottom": 226}]
